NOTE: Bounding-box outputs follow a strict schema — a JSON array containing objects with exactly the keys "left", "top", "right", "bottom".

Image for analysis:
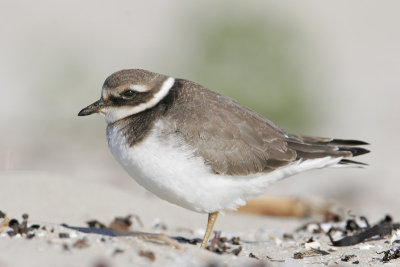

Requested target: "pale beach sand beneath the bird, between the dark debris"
[{"left": 0, "top": 172, "right": 400, "bottom": 267}]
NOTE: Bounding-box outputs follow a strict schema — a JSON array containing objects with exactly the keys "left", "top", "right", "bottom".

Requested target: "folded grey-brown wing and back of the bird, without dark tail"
[{"left": 163, "top": 81, "right": 296, "bottom": 175}]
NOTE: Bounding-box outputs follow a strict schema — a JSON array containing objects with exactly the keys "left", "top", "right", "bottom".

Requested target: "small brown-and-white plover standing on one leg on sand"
[{"left": 78, "top": 69, "right": 369, "bottom": 248}]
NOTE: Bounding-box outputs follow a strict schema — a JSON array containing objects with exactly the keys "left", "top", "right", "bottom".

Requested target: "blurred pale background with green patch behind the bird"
[{"left": 0, "top": 0, "right": 400, "bottom": 224}]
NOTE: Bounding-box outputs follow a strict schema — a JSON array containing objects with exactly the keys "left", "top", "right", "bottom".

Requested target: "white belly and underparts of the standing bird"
[{"left": 107, "top": 122, "right": 340, "bottom": 213}]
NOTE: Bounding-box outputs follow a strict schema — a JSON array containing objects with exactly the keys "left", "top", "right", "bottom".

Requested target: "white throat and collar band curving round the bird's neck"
[{"left": 100, "top": 77, "right": 175, "bottom": 124}]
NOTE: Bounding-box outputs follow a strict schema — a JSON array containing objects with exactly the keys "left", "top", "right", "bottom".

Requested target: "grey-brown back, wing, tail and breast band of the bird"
[{"left": 112, "top": 75, "right": 368, "bottom": 176}]
